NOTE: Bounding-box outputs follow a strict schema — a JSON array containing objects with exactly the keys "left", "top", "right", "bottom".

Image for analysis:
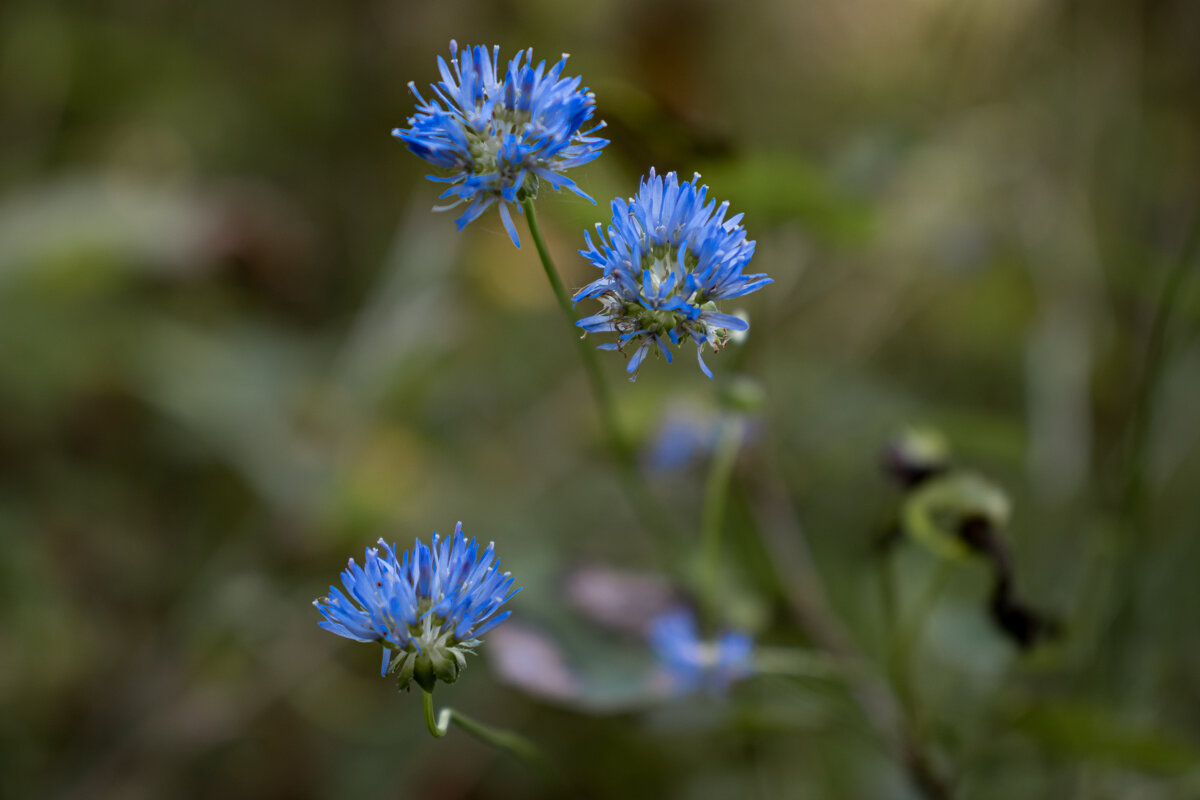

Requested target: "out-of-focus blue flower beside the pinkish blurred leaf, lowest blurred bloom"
[{"left": 649, "top": 608, "right": 754, "bottom": 692}]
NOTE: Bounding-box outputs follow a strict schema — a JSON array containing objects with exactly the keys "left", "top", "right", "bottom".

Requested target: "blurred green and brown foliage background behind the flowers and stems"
[{"left": 7, "top": 0, "right": 1200, "bottom": 799}]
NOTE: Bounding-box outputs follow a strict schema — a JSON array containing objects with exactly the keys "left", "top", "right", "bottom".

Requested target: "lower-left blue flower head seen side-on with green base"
[{"left": 313, "top": 522, "right": 520, "bottom": 692}]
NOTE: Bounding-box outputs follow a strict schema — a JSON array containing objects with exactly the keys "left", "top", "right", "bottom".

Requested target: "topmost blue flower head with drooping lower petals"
[{"left": 391, "top": 41, "right": 608, "bottom": 247}]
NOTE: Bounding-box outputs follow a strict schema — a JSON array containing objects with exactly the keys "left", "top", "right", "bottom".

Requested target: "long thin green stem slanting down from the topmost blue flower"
[{"left": 521, "top": 198, "right": 674, "bottom": 554}]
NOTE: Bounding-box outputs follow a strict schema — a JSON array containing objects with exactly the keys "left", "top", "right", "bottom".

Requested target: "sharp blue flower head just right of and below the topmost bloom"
[{"left": 574, "top": 169, "right": 772, "bottom": 379}]
